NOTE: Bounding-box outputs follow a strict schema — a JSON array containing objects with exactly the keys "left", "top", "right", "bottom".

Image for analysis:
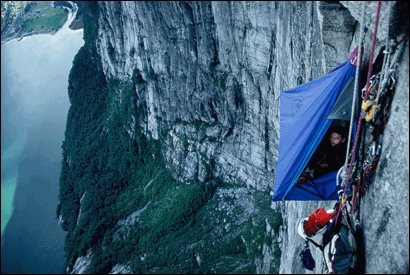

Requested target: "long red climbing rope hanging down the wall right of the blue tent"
[{"left": 335, "top": 0, "right": 382, "bottom": 223}]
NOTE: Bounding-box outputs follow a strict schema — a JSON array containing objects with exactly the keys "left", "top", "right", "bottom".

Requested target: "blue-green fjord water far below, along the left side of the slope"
[{"left": 1, "top": 5, "right": 84, "bottom": 274}]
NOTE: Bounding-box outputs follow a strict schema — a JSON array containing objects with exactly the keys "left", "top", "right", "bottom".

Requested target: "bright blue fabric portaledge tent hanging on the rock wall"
[{"left": 272, "top": 60, "right": 357, "bottom": 201}]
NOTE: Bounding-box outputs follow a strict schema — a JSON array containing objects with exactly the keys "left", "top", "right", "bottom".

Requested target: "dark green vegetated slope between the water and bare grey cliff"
[{"left": 57, "top": 3, "right": 282, "bottom": 273}]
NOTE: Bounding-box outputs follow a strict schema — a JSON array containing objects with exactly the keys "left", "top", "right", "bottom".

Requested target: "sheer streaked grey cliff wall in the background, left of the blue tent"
[{"left": 97, "top": 2, "right": 332, "bottom": 190}]
